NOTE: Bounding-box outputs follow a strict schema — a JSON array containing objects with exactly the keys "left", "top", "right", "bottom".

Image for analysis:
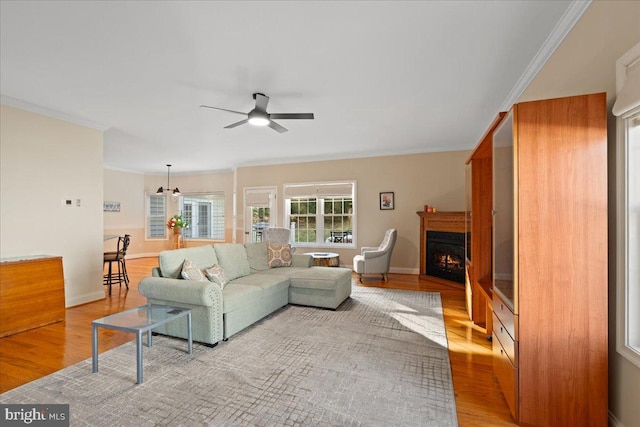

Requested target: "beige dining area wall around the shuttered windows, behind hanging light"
[{"left": 104, "top": 169, "right": 233, "bottom": 257}]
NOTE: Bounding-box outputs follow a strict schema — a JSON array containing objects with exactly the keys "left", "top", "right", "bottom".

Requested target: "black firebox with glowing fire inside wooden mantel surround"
[{"left": 426, "top": 231, "right": 465, "bottom": 283}]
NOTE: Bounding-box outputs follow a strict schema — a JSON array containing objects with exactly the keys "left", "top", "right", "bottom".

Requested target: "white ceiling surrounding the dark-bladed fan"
[{"left": 0, "top": 0, "right": 588, "bottom": 174}]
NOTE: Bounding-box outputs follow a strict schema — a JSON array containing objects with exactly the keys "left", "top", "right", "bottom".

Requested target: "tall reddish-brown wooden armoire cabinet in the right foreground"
[{"left": 471, "top": 93, "right": 608, "bottom": 426}]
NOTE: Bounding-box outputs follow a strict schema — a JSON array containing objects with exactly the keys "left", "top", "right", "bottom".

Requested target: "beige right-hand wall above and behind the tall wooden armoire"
[{"left": 519, "top": 1, "right": 640, "bottom": 427}]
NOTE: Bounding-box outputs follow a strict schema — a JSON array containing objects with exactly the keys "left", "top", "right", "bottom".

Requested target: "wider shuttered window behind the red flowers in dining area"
[{"left": 180, "top": 193, "right": 224, "bottom": 240}]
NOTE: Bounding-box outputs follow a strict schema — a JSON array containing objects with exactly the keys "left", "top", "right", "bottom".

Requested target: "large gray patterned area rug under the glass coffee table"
[{"left": 0, "top": 287, "right": 457, "bottom": 426}]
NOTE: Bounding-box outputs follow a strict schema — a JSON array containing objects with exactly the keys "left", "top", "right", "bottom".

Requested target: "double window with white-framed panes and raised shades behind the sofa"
[{"left": 284, "top": 182, "right": 356, "bottom": 248}]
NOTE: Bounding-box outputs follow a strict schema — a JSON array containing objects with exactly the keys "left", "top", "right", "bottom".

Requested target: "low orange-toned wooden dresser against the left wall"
[{"left": 0, "top": 256, "right": 65, "bottom": 337}]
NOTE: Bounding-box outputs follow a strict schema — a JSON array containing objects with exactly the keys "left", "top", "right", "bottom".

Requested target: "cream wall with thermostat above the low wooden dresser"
[{"left": 0, "top": 105, "right": 104, "bottom": 307}]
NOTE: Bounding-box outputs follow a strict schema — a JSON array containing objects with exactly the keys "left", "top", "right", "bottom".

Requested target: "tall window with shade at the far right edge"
[{"left": 613, "top": 43, "right": 640, "bottom": 367}]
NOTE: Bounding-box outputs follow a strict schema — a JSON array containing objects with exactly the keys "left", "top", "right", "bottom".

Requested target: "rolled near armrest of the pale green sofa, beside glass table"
[{"left": 138, "top": 277, "right": 222, "bottom": 307}]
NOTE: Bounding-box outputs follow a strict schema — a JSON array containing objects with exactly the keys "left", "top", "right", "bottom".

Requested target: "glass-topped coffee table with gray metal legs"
[{"left": 91, "top": 304, "right": 193, "bottom": 384}]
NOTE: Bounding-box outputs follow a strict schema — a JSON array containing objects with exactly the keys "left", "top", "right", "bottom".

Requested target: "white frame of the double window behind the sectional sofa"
[{"left": 283, "top": 180, "right": 357, "bottom": 249}]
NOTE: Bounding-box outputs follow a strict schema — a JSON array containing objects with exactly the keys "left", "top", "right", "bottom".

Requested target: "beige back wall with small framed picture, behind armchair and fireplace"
[{"left": 237, "top": 151, "right": 469, "bottom": 274}]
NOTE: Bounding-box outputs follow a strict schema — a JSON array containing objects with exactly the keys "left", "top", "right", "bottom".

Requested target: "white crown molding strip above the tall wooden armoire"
[{"left": 500, "top": 0, "right": 592, "bottom": 111}]
